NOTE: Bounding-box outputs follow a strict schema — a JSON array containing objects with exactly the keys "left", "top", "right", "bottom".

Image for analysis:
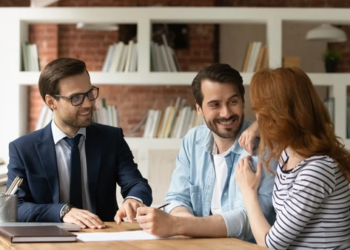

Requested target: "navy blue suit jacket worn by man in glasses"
[{"left": 7, "top": 123, "right": 152, "bottom": 222}]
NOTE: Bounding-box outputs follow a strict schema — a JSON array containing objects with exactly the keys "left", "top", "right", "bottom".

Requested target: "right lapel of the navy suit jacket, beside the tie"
[{"left": 85, "top": 125, "right": 103, "bottom": 213}]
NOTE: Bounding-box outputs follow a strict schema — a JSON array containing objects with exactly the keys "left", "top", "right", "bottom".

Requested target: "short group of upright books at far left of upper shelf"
[{"left": 22, "top": 42, "right": 40, "bottom": 71}]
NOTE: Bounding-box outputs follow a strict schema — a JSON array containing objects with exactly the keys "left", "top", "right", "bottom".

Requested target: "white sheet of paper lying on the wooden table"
[{"left": 76, "top": 230, "right": 163, "bottom": 241}]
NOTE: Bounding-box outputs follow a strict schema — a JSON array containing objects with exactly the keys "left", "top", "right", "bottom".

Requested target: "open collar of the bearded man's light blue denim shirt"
[{"left": 196, "top": 120, "right": 251, "bottom": 154}]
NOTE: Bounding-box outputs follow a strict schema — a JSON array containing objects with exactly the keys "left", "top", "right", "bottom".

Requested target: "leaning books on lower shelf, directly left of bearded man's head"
[{"left": 143, "top": 97, "right": 204, "bottom": 138}]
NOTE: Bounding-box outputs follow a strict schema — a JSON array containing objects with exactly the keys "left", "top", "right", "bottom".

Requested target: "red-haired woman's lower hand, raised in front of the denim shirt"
[{"left": 235, "top": 156, "right": 261, "bottom": 195}]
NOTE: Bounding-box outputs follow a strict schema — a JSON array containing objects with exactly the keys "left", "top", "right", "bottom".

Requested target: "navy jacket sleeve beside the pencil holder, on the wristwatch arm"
[{"left": 7, "top": 142, "right": 64, "bottom": 222}]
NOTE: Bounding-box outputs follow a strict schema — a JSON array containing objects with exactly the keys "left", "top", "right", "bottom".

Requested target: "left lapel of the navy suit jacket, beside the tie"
[{"left": 35, "top": 122, "right": 60, "bottom": 203}]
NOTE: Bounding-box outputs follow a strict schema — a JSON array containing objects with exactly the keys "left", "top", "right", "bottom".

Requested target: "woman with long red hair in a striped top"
[{"left": 236, "top": 68, "right": 350, "bottom": 249}]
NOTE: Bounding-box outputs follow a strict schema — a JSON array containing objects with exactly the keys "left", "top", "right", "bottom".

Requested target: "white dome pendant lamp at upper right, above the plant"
[{"left": 305, "top": 24, "right": 347, "bottom": 42}]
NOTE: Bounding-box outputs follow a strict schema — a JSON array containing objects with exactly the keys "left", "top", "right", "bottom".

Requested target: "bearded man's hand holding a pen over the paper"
[{"left": 136, "top": 207, "right": 181, "bottom": 237}]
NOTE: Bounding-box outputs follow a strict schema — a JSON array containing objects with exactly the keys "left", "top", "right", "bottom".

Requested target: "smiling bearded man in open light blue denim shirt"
[{"left": 137, "top": 64, "right": 275, "bottom": 241}]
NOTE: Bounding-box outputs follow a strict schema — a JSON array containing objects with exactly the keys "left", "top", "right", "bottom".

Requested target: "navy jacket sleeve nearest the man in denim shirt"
[{"left": 117, "top": 129, "right": 152, "bottom": 206}]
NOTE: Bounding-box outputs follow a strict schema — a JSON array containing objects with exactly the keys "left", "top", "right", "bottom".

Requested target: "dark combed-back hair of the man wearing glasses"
[{"left": 39, "top": 58, "right": 89, "bottom": 102}]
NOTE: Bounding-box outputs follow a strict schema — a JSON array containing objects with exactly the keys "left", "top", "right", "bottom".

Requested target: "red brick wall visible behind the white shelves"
[{"left": 9, "top": 0, "right": 350, "bottom": 131}]
